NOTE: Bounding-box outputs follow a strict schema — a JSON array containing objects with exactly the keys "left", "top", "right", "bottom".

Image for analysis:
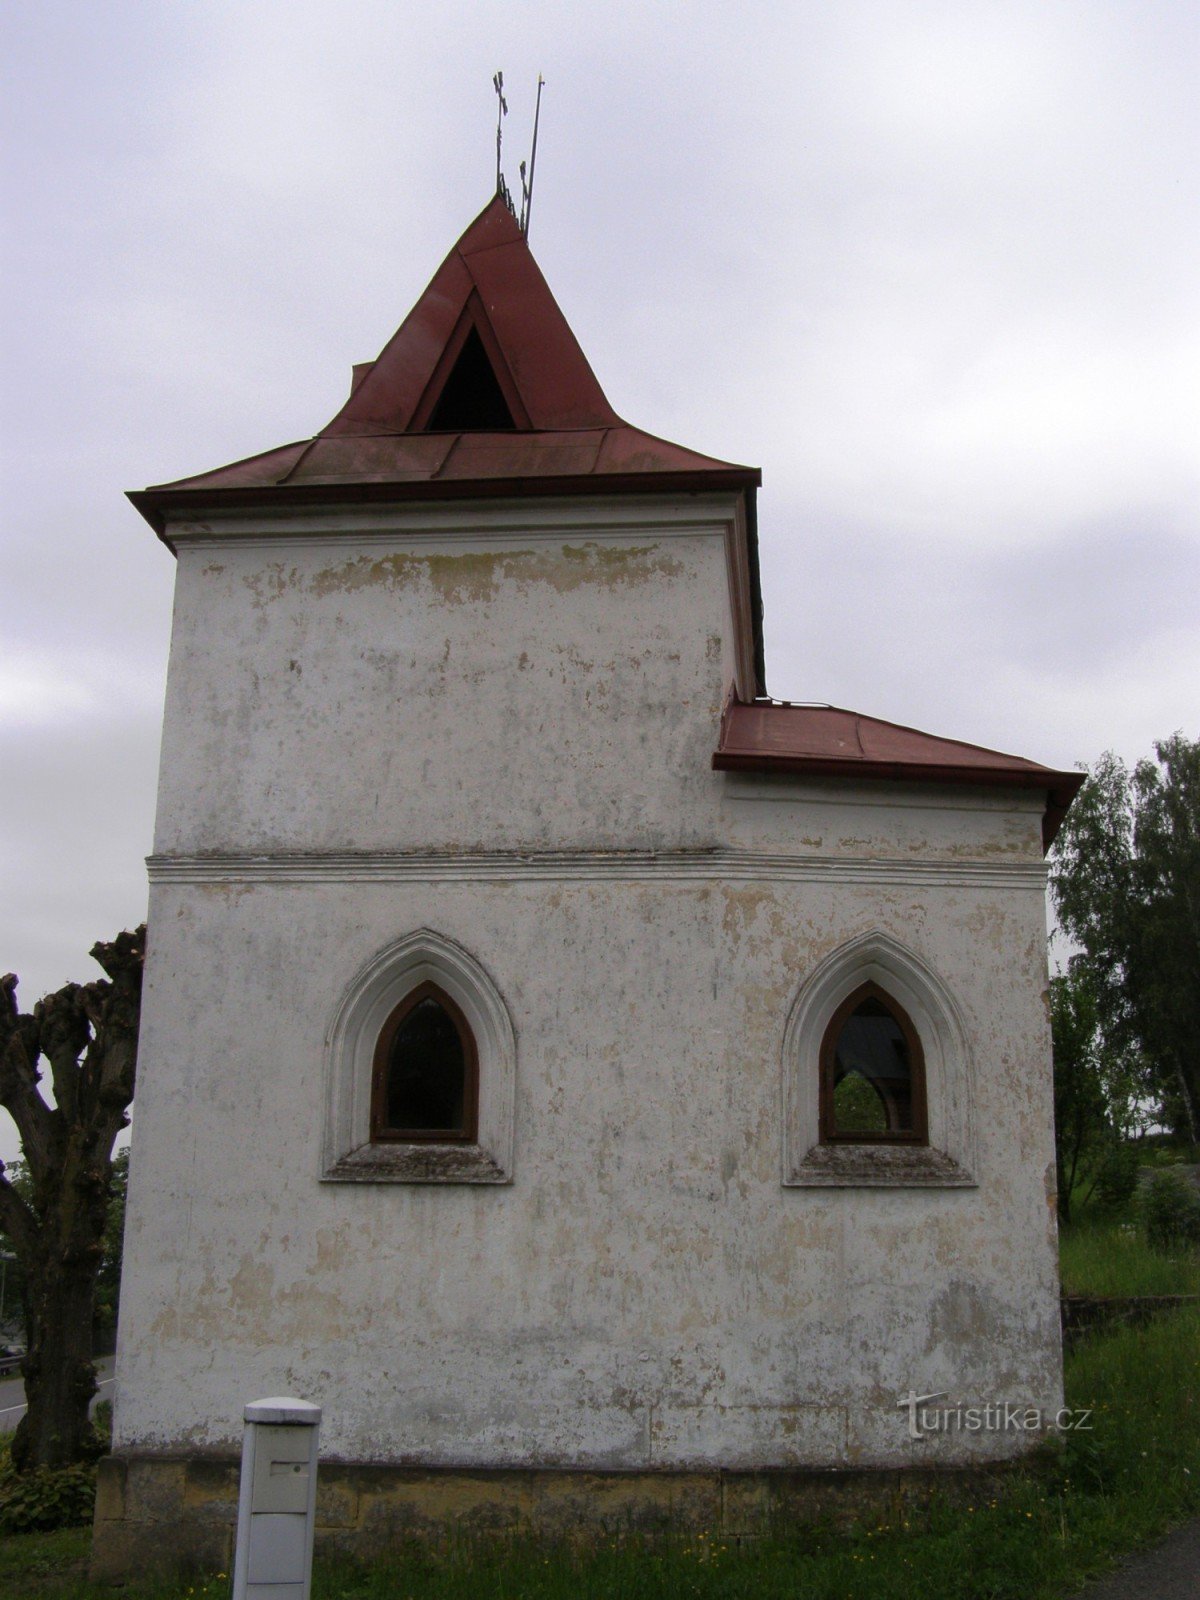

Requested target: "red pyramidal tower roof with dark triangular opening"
[{"left": 130, "top": 197, "right": 760, "bottom": 533}]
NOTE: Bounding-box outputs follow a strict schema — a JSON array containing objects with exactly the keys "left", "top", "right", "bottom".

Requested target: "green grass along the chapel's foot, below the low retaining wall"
[{"left": 0, "top": 1309, "right": 1200, "bottom": 1600}]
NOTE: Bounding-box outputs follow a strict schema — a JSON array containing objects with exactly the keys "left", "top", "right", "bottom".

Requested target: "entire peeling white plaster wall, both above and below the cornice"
[{"left": 115, "top": 489, "right": 1061, "bottom": 1467}]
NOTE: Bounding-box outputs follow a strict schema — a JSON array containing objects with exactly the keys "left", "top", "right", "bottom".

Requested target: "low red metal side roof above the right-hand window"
[{"left": 712, "top": 701, "right": 1083, "bottom": 850}]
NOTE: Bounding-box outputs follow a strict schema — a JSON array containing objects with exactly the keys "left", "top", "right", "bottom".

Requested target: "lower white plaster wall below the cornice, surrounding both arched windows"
[{"left": 118, "top": 857, "right": 1058, "bottom": 1466}]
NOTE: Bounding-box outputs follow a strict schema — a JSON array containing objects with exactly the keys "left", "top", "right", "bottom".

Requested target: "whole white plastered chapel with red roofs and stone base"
[{"left": 96, "top": 198, "right": 1080, "bottom": 1573}]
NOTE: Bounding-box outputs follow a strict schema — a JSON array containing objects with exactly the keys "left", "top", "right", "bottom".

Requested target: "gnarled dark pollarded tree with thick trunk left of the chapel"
[{"left": 0, "top": 926, "right": 146, "bottom": 1472}]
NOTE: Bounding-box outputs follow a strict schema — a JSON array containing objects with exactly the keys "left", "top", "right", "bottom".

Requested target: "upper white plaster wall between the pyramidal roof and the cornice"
[{"left": 155, "top": 498, "right": 733, "bottom": 851}]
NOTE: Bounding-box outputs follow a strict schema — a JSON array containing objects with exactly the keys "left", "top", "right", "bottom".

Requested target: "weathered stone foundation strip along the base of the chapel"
[{"left": 91, "top": 1454, "right": 1011, "bottom": 1582}]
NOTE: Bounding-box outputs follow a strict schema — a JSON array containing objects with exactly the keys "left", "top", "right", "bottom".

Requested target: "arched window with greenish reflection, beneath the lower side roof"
[{"left": 821, "top": 982, "right": 928, "bottom": 1144}]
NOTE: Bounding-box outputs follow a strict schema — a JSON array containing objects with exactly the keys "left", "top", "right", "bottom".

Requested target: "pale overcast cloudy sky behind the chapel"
[{"left": 0, "top": 0, "right": 1200, "bottom": 1154}]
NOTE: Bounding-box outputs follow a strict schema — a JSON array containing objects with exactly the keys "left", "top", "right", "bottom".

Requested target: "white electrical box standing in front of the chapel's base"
[{"left": 234, "top": 1395, "right": 322, "bottom": 1600}]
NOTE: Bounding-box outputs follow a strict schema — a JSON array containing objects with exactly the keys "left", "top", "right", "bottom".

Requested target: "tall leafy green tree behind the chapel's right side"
[{"left": 1051, "top": 733, "right": 1200, "bottom": 1144}]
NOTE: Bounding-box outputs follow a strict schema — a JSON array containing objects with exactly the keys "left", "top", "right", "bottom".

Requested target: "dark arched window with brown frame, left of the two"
[{"left": 371, "top": 982, "right": 478, "bottom": 1142}]
